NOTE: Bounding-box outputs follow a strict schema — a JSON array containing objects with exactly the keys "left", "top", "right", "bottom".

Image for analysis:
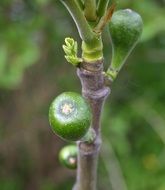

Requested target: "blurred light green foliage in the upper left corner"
[{"left": 0, "top": 0, "right": 39, "bottom": 88}]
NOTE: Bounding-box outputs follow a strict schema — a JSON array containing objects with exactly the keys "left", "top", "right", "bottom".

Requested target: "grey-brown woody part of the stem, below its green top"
[{"left": 73, "top": 60, "right": 110, "bottom": 190}]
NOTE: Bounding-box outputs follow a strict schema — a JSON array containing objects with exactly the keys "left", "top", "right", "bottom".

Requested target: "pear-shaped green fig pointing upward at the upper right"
[{"left": 107, "top": 9, "right": 143, "bottom": 79}]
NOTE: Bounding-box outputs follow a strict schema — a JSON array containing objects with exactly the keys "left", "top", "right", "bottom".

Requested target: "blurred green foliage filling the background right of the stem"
[{"left": 100, "top": 1, "right": 165, "bottom": 190}]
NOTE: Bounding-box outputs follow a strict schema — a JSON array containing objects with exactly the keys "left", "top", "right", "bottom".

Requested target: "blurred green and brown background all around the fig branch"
[{"left": 0, "top": 0, "right": 165, "bottom": 190}]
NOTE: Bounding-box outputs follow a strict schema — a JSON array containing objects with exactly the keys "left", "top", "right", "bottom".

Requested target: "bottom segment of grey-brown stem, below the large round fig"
[{"left": 73, "top": 139, "right": 101, "bottom": 190}]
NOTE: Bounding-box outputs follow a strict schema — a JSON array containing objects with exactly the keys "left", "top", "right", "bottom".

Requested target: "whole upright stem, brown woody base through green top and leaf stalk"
[{"left": 61, "top": 0, "right": 109, "bottom": 190}]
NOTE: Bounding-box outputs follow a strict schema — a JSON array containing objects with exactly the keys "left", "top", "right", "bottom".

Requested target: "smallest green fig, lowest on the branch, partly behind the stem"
[{"left": 59, "top": 145, "right": 78, "bottom": 169}]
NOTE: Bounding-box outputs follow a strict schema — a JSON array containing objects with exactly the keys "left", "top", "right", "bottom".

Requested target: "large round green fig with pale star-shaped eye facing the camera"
[{"left": 49, "top": 92, "right": 91, "bottom": 141}]
